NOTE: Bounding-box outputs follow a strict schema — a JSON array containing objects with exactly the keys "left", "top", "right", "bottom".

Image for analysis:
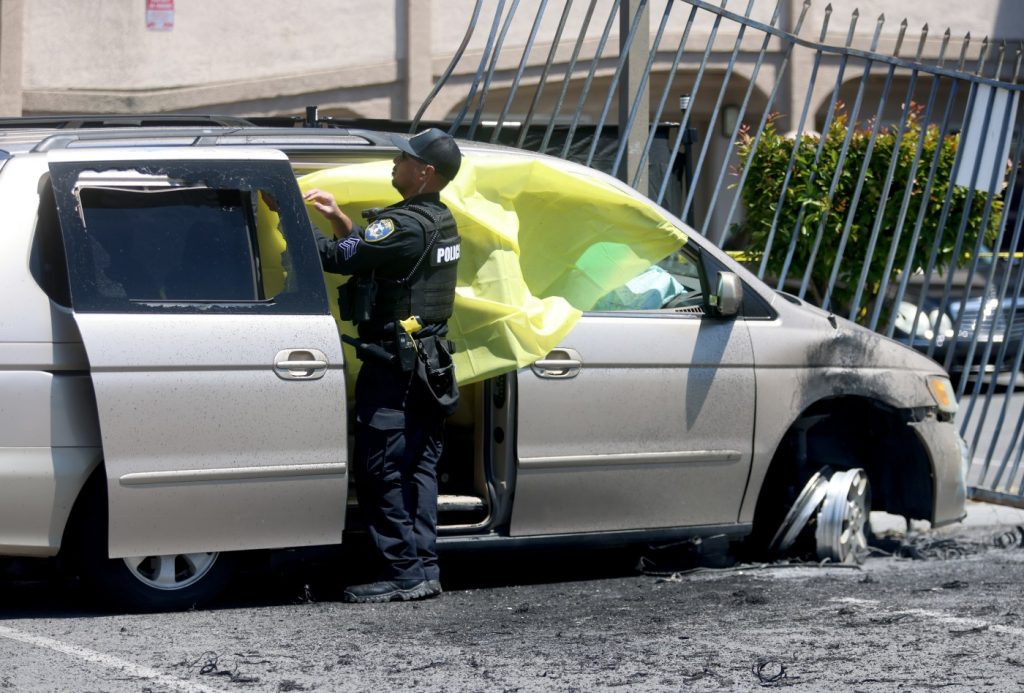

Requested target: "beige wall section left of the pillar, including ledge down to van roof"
[{"left": 23, "top": 0, "right": 404, "bottom": 117}]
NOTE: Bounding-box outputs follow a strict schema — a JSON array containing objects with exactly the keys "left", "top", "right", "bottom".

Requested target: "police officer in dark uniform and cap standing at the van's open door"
[{"left": 305, "top": 128, "right": 462, "bottom": 603}]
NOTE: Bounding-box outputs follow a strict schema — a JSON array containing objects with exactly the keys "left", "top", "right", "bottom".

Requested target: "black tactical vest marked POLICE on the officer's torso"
[{"left": 373, "top": 199, "right": 461, "bottom": 322}]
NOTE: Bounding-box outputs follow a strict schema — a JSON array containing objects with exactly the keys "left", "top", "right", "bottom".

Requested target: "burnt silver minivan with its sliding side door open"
[{"left": 0, "top": 125, "right": 966, "bottom": 609}]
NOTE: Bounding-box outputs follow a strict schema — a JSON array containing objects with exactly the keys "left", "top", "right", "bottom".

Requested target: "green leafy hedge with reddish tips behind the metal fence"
[{"left": 733, "top": 106, "right": 1002, "bottom": 319}]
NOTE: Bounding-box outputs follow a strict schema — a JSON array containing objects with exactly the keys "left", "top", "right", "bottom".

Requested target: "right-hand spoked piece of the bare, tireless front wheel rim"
[{"left": 814, "top": 469, "right": 870, "bottom": 563}]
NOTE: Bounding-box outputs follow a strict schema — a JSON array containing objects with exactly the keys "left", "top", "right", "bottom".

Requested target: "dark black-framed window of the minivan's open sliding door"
[{"left": 49, "top": 159, "right": 330, "bottom": 315}]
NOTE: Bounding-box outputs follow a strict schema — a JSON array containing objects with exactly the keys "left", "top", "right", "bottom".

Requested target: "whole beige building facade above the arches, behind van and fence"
[{"left": 0, "top": 0, "right": 1024, "bottom": 120}]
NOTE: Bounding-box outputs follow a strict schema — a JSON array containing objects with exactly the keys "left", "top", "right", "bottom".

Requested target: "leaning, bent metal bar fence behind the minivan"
[{"left": 416, "top": 0, "right": 1024, "bottom": 507}]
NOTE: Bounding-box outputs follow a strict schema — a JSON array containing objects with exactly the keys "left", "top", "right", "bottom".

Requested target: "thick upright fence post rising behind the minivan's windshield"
[{"left": 618, "top": 0, "right": 650, "bottom": 194}]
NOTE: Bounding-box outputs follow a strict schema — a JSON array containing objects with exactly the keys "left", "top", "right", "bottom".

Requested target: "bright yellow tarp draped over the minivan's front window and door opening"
[{"left": 272, "top": 155, "right": 686, "bottom": 384}]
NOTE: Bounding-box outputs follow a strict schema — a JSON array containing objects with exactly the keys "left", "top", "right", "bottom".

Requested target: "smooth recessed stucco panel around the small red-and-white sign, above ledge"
[{"left": 24, "top": 0, "right": 396, "bottom": 89}]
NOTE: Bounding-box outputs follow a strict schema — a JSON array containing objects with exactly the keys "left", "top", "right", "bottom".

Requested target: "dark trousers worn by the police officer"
[{"left": 352, "top": 359, "right": 444, "bottom": 580}]
